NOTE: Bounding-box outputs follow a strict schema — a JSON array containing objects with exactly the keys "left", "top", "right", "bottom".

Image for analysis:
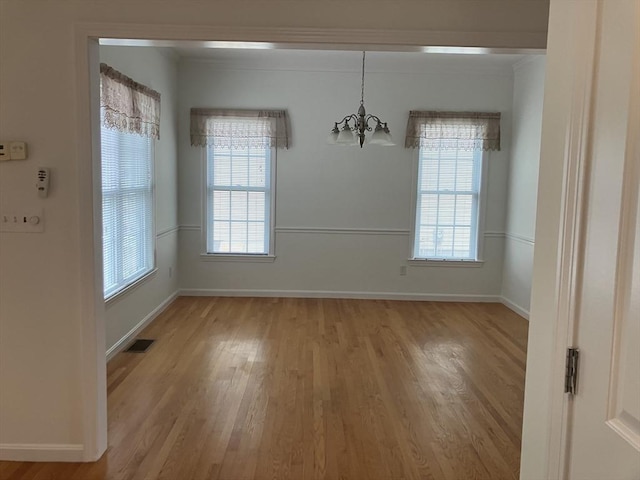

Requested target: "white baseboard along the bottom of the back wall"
[{"left": 180, "top": 288, "right": 502, "bottom": 303}]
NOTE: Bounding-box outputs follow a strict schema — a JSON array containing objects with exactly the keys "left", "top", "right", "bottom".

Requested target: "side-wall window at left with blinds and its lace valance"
[{"left": 100, "top": 63, "right": 160, "bottom": 299}]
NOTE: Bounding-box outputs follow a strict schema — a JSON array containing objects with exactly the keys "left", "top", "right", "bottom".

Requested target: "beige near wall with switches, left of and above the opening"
[{"left": 0, "top": 0, "right": 548, "bottom": 460}]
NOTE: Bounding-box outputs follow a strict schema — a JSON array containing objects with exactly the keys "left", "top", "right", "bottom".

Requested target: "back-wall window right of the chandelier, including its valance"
[{"left": 405, "top": 111, "right": 500, "bottom": 261}]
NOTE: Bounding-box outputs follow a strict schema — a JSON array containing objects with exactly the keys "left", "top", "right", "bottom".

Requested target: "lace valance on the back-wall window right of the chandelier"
[{"left": 404, "top": 111, "right": 500, "bottom": 150}]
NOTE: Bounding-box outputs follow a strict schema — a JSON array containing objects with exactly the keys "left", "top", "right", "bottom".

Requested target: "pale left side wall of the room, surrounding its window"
[{"left": 100, "top": 46, "right": 178, "bottom": 354}]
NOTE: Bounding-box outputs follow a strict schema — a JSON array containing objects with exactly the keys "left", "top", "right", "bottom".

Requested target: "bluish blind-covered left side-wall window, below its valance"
[{"left": 101, "top": 115, "right": 154, "bottom": 299}]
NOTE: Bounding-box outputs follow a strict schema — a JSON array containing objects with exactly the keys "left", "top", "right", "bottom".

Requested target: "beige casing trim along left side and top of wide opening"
[{"left": 74, "top": 22, "right": 546, "bottom": 462}]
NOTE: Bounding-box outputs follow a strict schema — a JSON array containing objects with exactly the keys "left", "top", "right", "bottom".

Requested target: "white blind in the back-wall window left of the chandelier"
[{"left": 206, "top": 119, "right": 272, "bottom": 255}]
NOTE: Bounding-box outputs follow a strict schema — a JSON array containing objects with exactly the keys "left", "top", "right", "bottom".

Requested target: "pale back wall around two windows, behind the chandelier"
[{"left": 179, "top": 52, "right": 513, "bottom": 300}]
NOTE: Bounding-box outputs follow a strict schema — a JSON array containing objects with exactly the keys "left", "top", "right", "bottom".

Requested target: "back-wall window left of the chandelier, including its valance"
[{"left": 191, "top": 108, "right": 289, "bottom": 261}]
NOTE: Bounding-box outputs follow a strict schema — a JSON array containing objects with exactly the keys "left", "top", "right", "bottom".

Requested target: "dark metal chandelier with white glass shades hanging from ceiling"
[{"left": 327, "top": 52, "right": 395, "bottom": 148}]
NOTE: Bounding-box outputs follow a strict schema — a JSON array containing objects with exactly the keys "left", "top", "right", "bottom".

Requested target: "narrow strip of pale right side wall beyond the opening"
[{"left": 502, "top": 56, "right": 545, "bottom": 318}]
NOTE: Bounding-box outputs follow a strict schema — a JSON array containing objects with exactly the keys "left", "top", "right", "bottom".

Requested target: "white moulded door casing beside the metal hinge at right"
[{"left": 543, "top": 0, "right": 601, "bottom": 480}]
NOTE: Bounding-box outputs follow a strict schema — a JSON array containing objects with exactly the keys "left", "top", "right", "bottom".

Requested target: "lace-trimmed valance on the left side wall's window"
[{"left": 100, "top": 63, "right": 160, "bottom": 139}]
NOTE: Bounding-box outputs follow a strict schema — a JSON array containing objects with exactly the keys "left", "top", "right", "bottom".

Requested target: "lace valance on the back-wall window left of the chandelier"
[{"left": 191, "top": 108, "right": 290, "bottom": 148}]
